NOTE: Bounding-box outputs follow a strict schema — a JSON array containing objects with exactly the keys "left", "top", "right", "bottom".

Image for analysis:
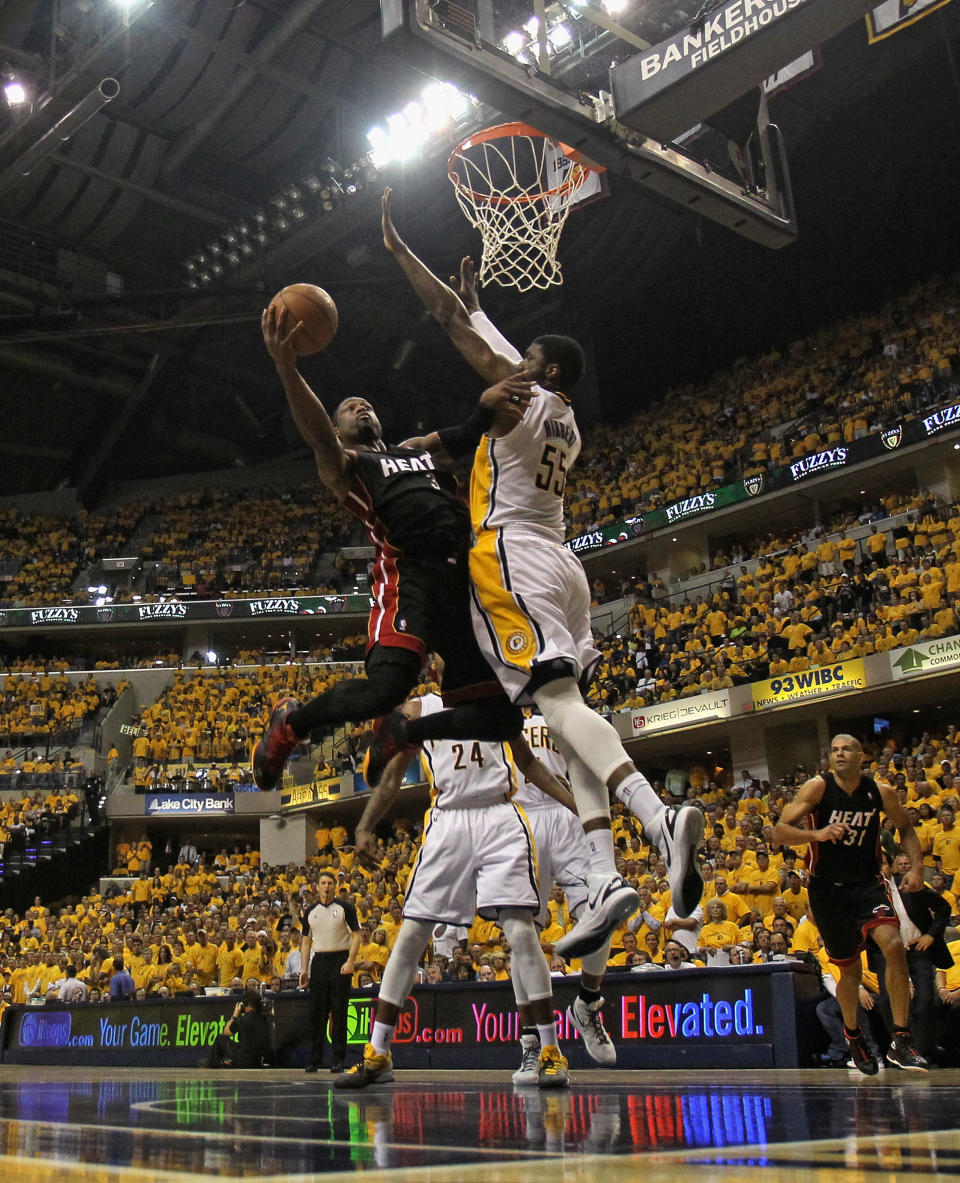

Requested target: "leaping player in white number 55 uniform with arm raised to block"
[{"left": 371, "top": 189, "right": 703, "bottom": 957}]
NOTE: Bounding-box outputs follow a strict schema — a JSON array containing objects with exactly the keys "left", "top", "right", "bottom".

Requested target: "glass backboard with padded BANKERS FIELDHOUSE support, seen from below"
[{"left": 381, "top": 0, "right": 885, "bottom": 247}]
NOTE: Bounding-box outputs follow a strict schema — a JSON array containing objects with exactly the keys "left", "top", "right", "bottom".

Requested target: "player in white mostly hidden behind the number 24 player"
[{"left": 514, "top": 713, "right": 617, "bottom": 1085}]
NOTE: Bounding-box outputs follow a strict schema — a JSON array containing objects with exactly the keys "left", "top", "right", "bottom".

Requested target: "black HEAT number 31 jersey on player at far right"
[{"left": 807, "top": 772, "right": 883, "bottom": 883}]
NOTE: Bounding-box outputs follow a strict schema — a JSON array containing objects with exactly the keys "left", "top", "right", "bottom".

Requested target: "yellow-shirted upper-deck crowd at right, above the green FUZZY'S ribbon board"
[{"left": 567, "top": 276, "right": 960, "bottom": 535}]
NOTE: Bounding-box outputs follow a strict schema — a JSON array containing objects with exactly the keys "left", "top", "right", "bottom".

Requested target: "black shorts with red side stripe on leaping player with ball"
[{"left": 367, "top": 552, "right": 501, "bottom": 700}]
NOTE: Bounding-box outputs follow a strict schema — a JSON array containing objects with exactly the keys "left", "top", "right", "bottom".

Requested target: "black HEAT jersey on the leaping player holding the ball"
[{"left": 343, "top": 447, "right": 470, "bottom": 560}]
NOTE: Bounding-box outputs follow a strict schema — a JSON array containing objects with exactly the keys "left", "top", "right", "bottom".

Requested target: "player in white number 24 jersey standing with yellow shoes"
[{"left": 334, "top": 694, "right": 568, "bottom": 1088}]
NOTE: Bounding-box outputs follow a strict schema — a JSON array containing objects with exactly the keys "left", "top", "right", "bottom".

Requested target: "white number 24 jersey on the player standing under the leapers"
[{"left": 420, "top": 694, "right": 517, "bottom": 809}]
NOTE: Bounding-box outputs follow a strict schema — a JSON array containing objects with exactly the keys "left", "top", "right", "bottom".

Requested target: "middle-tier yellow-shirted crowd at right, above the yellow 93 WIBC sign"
[{"left": 582, "top": 493, "right": 960, "bottom": 711}]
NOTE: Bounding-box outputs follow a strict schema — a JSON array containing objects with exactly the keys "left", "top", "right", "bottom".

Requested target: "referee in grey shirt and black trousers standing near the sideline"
[{"left": 299, "top": 871, "right": 360, "bottom": 1072}]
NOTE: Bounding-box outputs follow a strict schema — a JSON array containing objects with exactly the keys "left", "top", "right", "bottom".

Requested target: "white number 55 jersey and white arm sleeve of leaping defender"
[{"left": 470, "top": 312, "right": 580, "bottom": 545}]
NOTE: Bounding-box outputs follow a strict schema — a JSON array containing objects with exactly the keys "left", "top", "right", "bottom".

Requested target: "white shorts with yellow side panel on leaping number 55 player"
[{"left": 470, "top": 530, "right": 600, "bottom": 704}]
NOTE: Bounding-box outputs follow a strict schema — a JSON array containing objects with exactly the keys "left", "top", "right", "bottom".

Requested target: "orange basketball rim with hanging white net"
[{"left": 446, "top": 123, "right": 600, "bottom": 292}]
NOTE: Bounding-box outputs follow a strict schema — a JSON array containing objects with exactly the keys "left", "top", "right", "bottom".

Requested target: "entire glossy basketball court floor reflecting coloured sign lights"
[{"left": 0, "top": 1067, "right": 960, "bottom": 1183}]
